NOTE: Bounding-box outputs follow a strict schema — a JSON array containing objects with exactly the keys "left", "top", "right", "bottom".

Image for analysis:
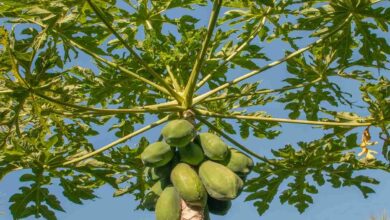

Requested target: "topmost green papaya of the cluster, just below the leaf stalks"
[{"left": 161, "top": 119, "right": 196, "bottom": 147}]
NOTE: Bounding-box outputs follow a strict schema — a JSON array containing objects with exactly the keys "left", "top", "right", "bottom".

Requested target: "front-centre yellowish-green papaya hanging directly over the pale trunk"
[{"left": 171, "top": 163, "right": 207, "bottom": 207}]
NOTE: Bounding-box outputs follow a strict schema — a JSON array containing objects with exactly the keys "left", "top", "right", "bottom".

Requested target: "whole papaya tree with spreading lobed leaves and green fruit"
[{"left": 0, "top": 0, "right": 390, "bottom": 219}]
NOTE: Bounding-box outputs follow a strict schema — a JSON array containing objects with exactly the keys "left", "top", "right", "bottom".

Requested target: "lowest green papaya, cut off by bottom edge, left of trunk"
[{"left": 155, "top": 186, "right": 181, "bottom": 220}]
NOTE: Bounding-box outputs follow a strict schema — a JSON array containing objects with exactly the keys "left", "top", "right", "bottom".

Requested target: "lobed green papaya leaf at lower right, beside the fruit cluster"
[{"left": 245, "top": 134, "right": 388, "bottom": 215}]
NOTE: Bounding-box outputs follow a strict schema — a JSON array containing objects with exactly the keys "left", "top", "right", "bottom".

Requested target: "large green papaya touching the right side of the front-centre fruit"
[{"left": 199, "top": 160, "right": 244, "bottom": 200}]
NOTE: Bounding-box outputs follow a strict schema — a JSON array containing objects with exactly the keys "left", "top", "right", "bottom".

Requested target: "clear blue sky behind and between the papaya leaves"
[{"left": 0, "top": 0, "right": 390, "bottom": 220}]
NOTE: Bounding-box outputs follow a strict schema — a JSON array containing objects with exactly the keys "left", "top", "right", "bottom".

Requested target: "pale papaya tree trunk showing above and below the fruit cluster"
[{"left": 180, "top": 110, "right": 206, "bottom": 220}]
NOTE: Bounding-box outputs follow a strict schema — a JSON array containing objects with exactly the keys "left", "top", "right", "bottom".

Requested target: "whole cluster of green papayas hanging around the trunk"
[{"left": 141, "top": 119, "right": 253, "bottom": 220}]
